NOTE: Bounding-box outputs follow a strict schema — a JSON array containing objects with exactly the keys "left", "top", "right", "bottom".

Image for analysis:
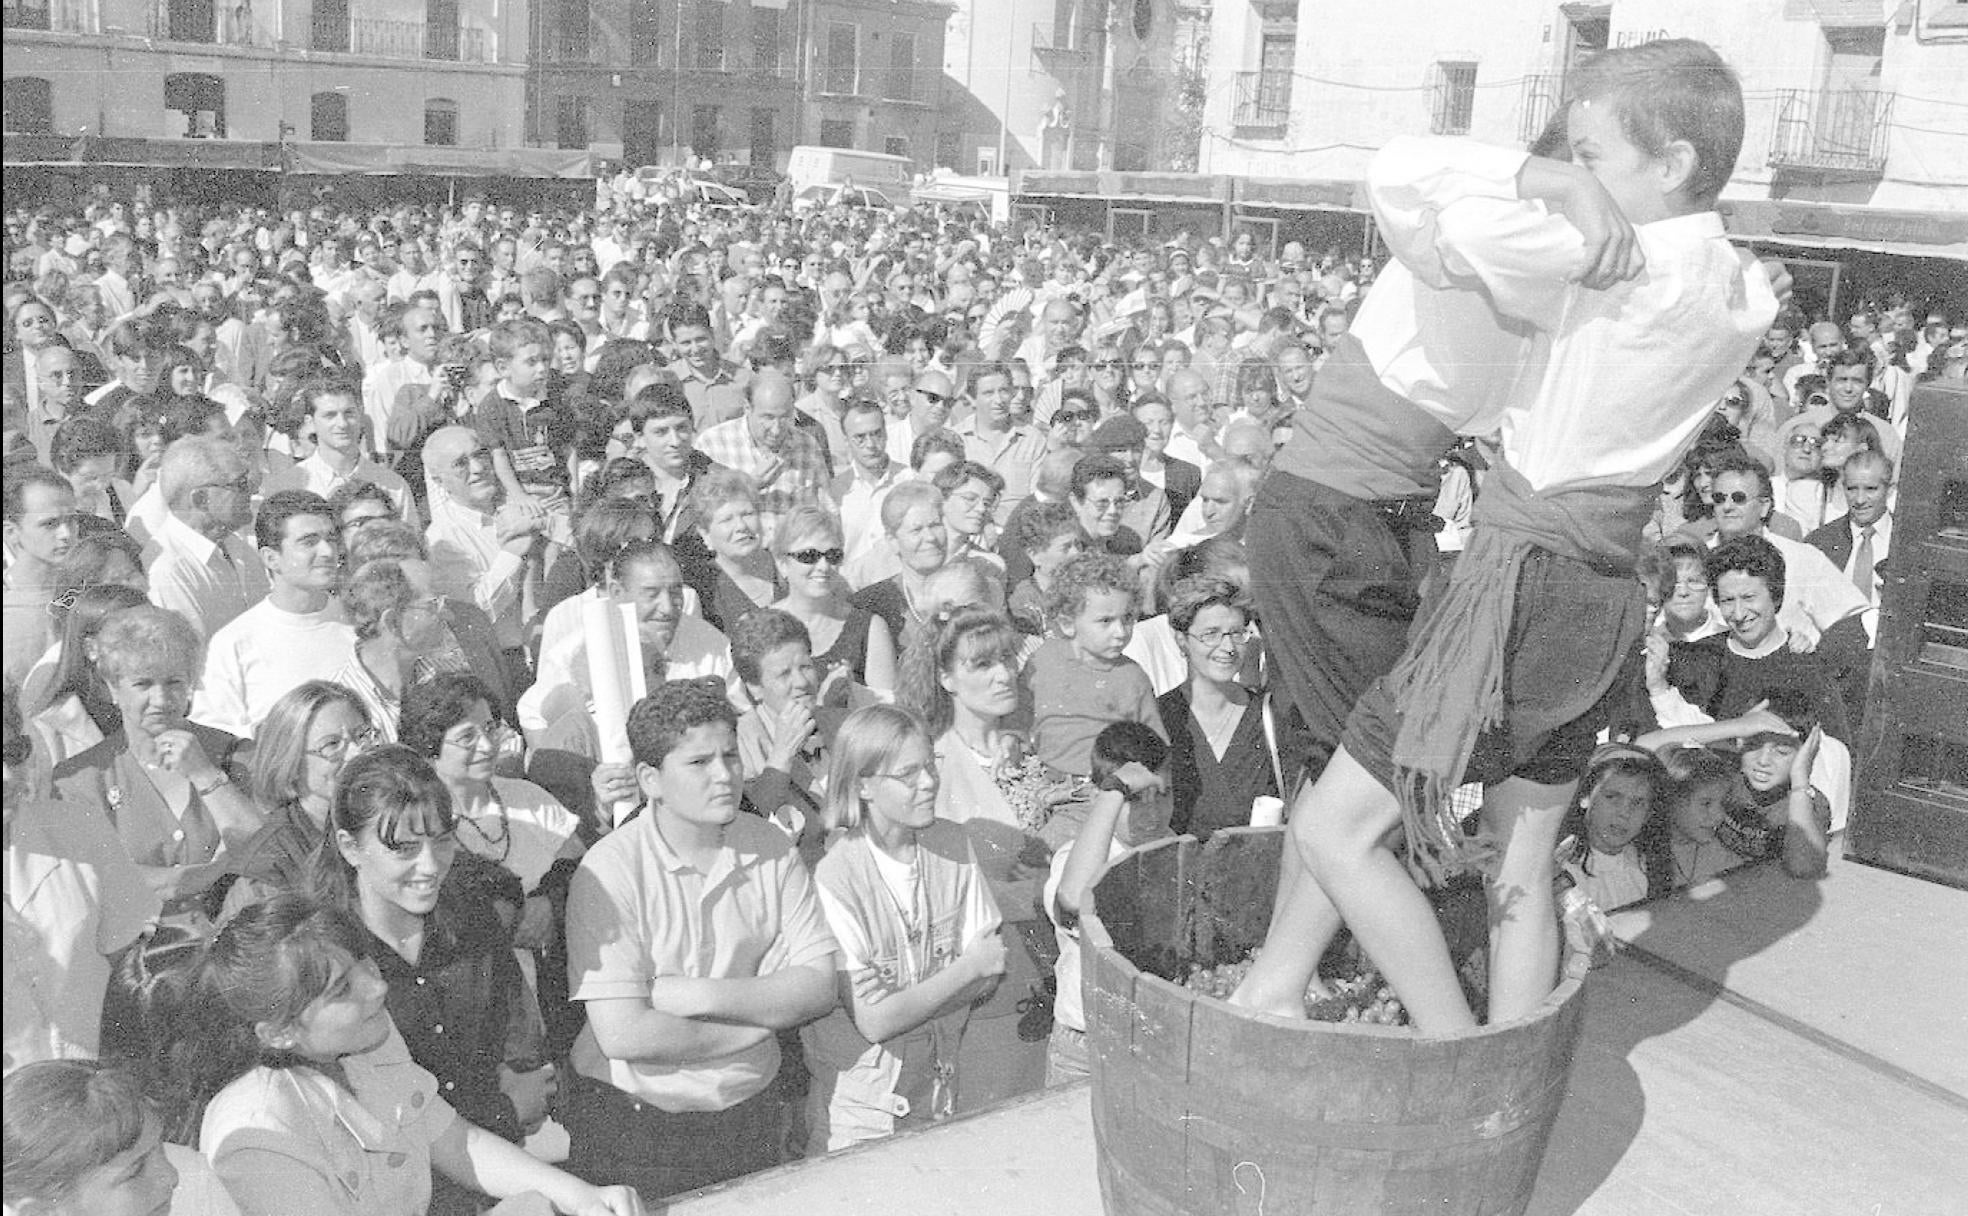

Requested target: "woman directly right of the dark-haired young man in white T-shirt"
[{"left": 335, "top": 559, "right": 464, "bottom": 740}]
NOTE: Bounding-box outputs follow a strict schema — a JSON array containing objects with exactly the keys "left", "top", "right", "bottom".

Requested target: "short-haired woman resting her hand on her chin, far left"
[{"left": 55, "top": 608, "right": 260, "bottom": 921}]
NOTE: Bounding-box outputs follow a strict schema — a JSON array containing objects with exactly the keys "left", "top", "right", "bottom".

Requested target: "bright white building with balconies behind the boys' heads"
[{"left": 1200, "top": 0, "right": 1968, "bottom": 229}]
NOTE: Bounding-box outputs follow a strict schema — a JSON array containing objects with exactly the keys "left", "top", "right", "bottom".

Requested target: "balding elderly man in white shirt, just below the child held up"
[{"left": 423, "top": 427, "right": 551, "bottom": 676}]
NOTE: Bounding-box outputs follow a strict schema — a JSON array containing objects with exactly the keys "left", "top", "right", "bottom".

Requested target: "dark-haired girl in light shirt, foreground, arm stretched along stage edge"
[{"left": 159, "top": 895, "right": 642, "bottom": 1216}]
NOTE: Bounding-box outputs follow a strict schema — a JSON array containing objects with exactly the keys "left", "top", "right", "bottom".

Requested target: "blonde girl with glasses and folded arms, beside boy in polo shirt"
[{"left": 801, "top": 704, "right": 1006, "bottom": 1155}]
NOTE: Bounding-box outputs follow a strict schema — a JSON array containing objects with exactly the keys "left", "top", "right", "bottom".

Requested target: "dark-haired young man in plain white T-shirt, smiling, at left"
[{"left": 191, "top": 490, "right": 356, "bottom": 738}]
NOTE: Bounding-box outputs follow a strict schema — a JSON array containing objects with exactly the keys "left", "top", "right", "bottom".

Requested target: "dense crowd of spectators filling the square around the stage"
[{"left": 4, "top": 96, "right": 1968, "bottom": 1216}]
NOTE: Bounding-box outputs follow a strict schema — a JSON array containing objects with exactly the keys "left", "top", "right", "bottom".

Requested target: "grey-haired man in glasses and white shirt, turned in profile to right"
[{"left": 148, "top": 435, "right": 268, "bottom": 638}]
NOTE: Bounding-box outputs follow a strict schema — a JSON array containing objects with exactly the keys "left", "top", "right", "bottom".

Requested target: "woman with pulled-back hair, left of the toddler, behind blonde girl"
[{"left": 897, "top": 608, "right": 1075, "bottom": 1110}]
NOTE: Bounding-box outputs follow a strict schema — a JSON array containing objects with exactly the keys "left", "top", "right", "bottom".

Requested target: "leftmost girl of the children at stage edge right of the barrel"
[{"left": 1559, "top": 744, "right": 1669, "bottom": 911}]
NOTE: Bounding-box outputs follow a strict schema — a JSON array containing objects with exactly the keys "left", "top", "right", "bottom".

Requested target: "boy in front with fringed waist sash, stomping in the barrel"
[{"left": 1234, "top": 39, "right": 1777, "bottom": 1033}]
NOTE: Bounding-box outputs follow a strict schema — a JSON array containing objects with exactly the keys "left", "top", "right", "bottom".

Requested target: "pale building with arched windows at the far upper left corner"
[{"left": 6, "top": 0, "right": 525, "bottom": 148}]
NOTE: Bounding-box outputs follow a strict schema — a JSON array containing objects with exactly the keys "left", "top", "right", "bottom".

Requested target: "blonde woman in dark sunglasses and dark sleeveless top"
[{"left": 771, "top": 506, "right": 895, "bottom": 693}]
